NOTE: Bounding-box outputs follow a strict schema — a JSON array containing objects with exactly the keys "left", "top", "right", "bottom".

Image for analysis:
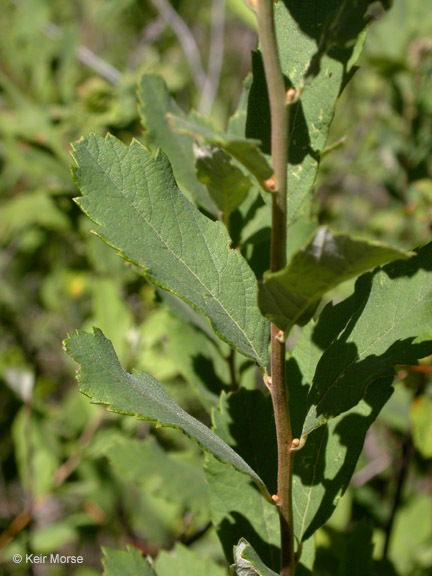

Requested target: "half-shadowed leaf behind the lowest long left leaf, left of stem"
[{"left": 205, "top": 389, "right": 280, "bottom": 570}]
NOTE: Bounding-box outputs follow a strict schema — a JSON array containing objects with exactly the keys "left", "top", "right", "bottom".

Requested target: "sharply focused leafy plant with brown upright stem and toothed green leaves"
[{"left": 65, "top": 0, "right": 432, "bottom": 576}]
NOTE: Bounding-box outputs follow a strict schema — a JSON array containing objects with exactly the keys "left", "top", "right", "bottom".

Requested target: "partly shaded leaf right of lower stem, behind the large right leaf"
[{"left": 286, "top": 326, "right": 392, "bottom": 544}]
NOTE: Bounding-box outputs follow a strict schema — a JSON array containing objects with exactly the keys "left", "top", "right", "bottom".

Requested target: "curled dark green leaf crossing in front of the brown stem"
[{"left": 258, "top": 226, "right": 409, "bottom": 333}]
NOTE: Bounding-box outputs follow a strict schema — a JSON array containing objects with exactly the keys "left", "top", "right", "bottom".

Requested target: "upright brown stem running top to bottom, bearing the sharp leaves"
[{"left": 255, "top": 0, "right": 295, "bottom": 576}]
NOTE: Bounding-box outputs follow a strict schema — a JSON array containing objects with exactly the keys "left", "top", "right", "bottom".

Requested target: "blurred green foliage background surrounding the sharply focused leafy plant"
[{"left": 0, "top": 0, "right": 432, "bottom": 576}]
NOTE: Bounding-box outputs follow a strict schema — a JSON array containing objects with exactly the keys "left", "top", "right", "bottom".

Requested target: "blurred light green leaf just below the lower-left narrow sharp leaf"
[{"left": 104, "top": 437, "right": 209, "bottom": 514}]
